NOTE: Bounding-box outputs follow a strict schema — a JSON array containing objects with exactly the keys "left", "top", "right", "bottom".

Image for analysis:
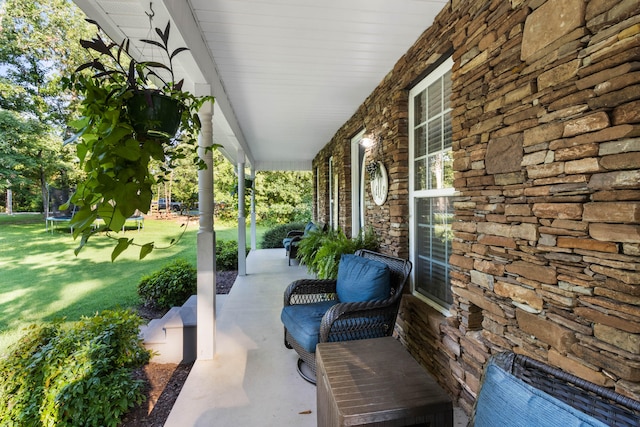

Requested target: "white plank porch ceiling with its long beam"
[{"left": 74, "top": 0, "right": 447, "bottom": 170}]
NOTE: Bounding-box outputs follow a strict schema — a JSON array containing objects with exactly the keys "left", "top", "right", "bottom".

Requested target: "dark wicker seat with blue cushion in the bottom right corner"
[{"left": 472, "top": 352, "right": 640, "bottom": 427}]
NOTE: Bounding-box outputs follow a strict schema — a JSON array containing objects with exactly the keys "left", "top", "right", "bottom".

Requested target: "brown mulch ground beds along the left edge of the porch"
[{"left": 120, "top": 271, "right": 238, "bottom": 427}]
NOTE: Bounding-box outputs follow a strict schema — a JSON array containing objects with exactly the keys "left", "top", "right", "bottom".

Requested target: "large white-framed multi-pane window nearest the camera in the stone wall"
[{"left": 409, "top": 58, "right": 454, "bottom": 312}]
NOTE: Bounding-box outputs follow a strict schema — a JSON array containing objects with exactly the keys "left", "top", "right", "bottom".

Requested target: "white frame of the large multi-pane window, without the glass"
[{"left": 409, "top": 57, "right": 455, "bottom": 316}]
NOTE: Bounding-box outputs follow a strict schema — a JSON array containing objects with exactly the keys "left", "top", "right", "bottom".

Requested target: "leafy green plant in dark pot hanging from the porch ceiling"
[{"left": 66, "top": 20, "right": 214, "bottom": 260}]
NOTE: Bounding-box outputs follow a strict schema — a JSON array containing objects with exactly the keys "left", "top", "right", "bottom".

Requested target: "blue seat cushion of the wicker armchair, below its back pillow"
[{"left": 280, "top": 300, "right": 338, "bottom": 353}]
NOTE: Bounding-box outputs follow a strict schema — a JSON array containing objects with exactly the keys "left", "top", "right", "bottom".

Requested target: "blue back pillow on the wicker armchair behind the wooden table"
[{"left": 336, "top": 254, "right": 391, "bottom": 302}]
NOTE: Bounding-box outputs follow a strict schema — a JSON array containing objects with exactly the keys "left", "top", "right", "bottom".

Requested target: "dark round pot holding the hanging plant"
[{"left": 127, "top": 91, "right": 182, "bottom": 139}]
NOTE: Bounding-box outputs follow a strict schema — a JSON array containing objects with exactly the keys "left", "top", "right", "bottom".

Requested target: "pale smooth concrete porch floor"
[{"left": 165, "top": 249, "right": 467, "bottom": 427}]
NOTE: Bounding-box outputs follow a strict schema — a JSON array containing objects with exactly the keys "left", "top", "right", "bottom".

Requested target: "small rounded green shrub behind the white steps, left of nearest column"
[{"left": 138, "top": 259, "right": 198, "bottom": 310}]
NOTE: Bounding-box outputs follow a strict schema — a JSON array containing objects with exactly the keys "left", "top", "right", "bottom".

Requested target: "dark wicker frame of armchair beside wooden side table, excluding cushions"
[{"left": 283, "top": 249, "right": 411, "bottom": 384}]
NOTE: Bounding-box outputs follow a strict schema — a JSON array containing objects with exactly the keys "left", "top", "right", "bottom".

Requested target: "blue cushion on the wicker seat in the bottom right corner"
[{"left": 475, "top": 361, "right": 606, "bottom": 427}]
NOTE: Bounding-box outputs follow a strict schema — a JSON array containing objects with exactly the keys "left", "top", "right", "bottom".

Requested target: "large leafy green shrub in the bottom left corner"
[{"left": 0, "top": 310, "right": 150, "bottom": 427}]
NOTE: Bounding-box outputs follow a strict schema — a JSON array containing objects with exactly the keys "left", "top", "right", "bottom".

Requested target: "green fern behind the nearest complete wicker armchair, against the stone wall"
[{"left": 298, "top": 228, "right": 379, "bottom": 279}]
